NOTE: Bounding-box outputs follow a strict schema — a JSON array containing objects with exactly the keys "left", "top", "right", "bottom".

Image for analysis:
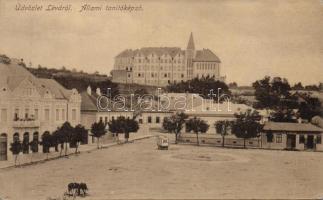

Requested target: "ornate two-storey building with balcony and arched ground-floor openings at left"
[{"left": 0, "top": 59, "right": 81, "bottom": 160}]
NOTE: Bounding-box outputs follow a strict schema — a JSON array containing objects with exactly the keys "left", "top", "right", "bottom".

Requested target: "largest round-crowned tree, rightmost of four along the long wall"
[{"left": 232, "top": 110, "right": 262, "bottom": 148}]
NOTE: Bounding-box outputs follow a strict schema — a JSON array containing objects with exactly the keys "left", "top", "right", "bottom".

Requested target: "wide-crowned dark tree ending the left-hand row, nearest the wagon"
[{"left": 108, "top": 116, "right": 139, "bottom": 142}]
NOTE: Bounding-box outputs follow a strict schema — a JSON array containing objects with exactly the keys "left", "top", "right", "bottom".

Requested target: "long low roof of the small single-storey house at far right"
[{"left": 263, "top": 122, "right": 323, "bottom": 132}]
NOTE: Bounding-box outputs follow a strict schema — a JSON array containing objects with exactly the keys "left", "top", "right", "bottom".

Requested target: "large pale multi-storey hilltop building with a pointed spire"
[{"left": 112, "top": 33, "right": 225, "bottom": 86}]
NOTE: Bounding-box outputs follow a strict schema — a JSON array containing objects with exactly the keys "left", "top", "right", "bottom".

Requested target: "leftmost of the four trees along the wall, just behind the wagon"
[{"left": 163, "top": 112, "right": 188, "bottom": 144}]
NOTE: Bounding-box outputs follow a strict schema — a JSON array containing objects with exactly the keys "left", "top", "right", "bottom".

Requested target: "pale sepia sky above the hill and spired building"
[{"left": 0, "top": 0, "right": 323, "bottom": 85}]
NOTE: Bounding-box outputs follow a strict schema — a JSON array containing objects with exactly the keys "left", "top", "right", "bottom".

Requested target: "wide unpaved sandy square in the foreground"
[{"left": 0, "top": 138, "right": 323, "bottom": 200}]
